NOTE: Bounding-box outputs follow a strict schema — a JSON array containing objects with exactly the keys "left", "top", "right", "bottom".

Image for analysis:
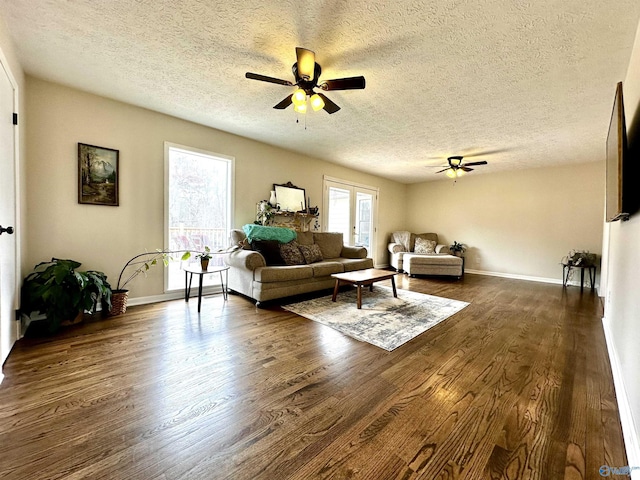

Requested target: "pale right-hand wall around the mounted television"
[{"left": 603, "top": 18, "right": 640, "bottom": 465}]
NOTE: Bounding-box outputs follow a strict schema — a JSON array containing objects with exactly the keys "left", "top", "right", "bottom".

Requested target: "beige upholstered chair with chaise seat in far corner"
[{"left": 388, "top": 231, "right": 464, "bottom": 278}]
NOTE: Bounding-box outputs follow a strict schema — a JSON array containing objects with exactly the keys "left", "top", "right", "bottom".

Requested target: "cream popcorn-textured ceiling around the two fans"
[{"left": 0, "top": 0, "right": 640, "bottom": 183}]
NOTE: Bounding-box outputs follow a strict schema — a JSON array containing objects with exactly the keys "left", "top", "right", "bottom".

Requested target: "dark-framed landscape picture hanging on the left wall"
[{"left": 78, "top": 143, "right": 120, "bottom": 206}]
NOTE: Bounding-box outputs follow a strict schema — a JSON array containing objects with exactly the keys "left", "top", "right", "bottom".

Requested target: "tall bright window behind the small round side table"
[{"left": 165, "top": 143, "right": 234, "bottom": 290}]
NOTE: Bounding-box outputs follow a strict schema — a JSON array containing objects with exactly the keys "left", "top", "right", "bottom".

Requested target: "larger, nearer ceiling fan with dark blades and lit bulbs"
[{"left": 245, "top": 47, "right": 365, "bottom": 113}]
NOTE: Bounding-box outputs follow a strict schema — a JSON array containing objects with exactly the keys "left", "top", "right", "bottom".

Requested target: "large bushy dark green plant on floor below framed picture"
[{"left": 20, "top": 258, "right": 111, "bottom": 333}]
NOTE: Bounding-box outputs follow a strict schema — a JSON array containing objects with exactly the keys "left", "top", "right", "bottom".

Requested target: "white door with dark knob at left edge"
[{"left": 0, "top": 61, "right": 19, "bottom": 370}]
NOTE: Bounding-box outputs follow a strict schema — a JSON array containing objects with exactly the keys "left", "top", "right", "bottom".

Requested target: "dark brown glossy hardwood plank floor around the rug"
[{"left": 0, "top": 275, "right": 627, "bottom": 480}]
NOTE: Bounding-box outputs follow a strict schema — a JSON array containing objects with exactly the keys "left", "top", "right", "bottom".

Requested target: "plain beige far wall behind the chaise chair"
[{"left": 407, "top": 160, "right": 605, "bottom": 281}]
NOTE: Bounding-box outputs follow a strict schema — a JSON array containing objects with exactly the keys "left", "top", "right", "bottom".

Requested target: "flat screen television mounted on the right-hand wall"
[{"left": 606, "top": 82, "right": 631, "bottom": 222}]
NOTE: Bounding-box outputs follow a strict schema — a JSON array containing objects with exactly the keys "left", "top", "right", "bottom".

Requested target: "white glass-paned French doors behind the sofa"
[{"left": 323, "top": 176, "right": 378, "bottom": 264}]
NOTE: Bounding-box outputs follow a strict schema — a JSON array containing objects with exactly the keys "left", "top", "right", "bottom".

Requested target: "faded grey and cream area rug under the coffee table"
[{"left": 282, "top": 285, "right": 469, "bottom": 352}]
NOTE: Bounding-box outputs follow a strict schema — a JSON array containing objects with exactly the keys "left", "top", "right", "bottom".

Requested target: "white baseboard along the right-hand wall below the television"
[{"left": 602, "top": 317, "right": 640, "bottom": 480}]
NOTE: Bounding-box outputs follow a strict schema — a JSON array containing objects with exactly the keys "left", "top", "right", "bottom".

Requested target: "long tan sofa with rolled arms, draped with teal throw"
[{"left": 225, "top": 230, "right": 373, "bottom": 305}]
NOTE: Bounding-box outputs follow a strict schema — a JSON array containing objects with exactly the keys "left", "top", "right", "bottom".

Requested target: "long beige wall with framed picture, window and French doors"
[{"left": 23, "top": 77, "right": 406, "bottom": 297}]
